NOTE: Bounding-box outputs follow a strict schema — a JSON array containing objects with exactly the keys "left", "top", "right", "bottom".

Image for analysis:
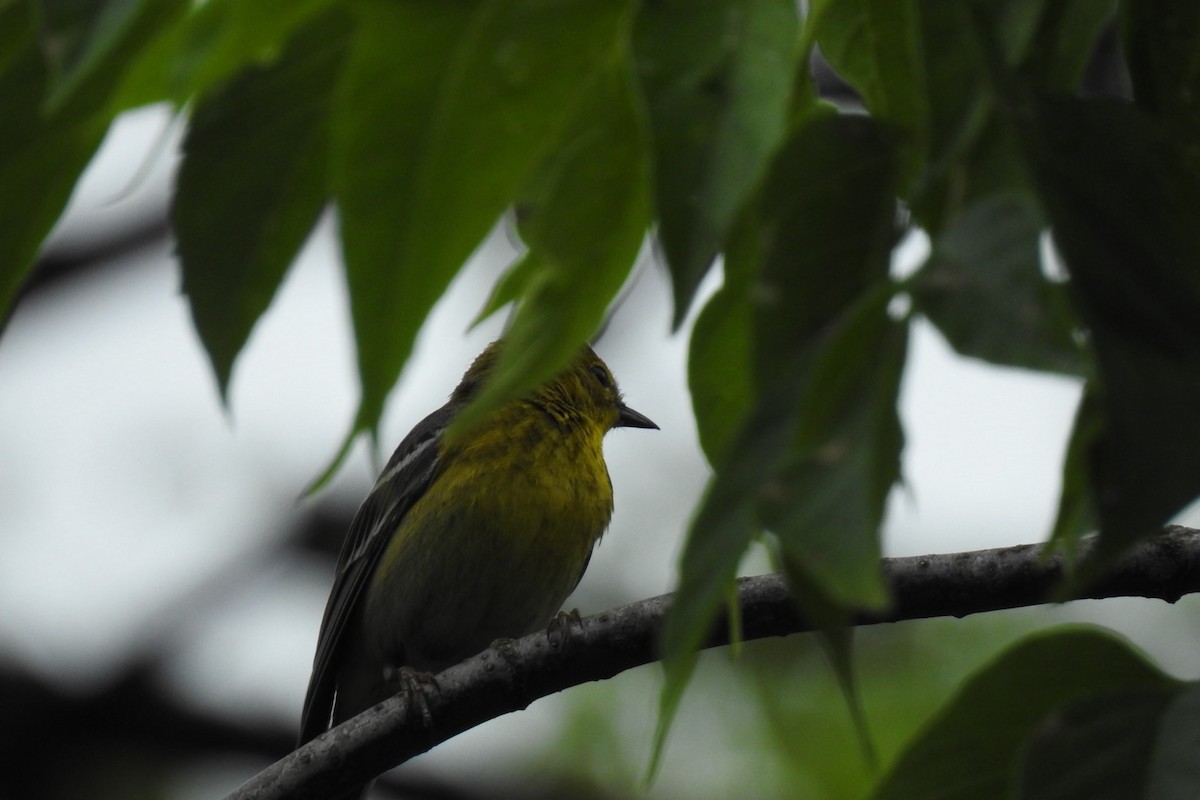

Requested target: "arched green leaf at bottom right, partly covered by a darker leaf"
[{"left": 872, "top": 627, "right": 1176, "bottom": 800}]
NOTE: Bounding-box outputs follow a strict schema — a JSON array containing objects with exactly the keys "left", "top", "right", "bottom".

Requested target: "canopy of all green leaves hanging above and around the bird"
[{"left": 7, "top": 0, "right": 1200, "bottom": 798}]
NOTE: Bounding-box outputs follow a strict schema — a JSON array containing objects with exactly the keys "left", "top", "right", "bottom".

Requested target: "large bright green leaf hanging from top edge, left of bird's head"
[{"left": 334, "top": 0, "right": 626, "bottom": 441}]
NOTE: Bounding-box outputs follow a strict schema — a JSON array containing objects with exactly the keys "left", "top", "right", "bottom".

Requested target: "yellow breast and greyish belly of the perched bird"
[{"left": 366, "top": 409, "right": 612, "bottom": 670}]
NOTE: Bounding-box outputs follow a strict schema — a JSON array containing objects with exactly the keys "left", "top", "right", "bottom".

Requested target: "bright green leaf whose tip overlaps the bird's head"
[{"left": 448, "top": 64, "right": 649, "bottom": 433}]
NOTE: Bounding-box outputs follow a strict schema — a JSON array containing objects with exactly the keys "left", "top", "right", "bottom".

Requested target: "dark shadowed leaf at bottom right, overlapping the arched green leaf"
[{"left": 1020, "top": 687, "right": 1180, "bottom": 800}]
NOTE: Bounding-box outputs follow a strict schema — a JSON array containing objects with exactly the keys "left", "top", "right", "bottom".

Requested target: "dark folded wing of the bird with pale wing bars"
[{"left": 300, "top": 405, "right": 455, "bottom": 744}]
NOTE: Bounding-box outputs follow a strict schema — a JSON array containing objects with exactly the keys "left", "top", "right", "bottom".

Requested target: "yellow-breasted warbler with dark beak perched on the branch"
[{"left": 300, "top": 341, "right": 658, "bottom": 782}]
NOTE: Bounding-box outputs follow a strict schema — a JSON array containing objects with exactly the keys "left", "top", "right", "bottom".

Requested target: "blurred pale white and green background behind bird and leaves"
[{"left": 7, "top": 43, "right": 1200, "bottom": 800}]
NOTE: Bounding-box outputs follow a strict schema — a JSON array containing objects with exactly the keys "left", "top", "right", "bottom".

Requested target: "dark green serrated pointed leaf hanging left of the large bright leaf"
[{"left": 172, "top": 13, "right": 350, "bottom": 398}]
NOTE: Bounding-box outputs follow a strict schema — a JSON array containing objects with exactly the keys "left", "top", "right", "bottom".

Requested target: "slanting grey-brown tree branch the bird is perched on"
[{"left": 229, "top": 527, "right": 1200, "bottom": 800}]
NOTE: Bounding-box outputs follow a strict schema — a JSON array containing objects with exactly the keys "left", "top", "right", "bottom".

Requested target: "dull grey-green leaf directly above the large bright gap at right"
[{"left": 912, "top": 193, "right": 1084, "bottom": 375}]
